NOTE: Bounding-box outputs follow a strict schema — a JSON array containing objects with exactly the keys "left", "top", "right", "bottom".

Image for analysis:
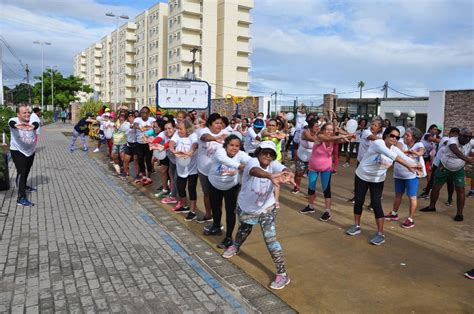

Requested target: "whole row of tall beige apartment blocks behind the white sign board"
[{"left": 74, "top": 0, "right": 254, "bottom": 108}]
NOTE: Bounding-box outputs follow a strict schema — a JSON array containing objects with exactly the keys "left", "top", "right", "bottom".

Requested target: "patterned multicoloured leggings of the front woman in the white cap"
[{"left": 234, "top": 206, "right": 286, "bottom": 274}]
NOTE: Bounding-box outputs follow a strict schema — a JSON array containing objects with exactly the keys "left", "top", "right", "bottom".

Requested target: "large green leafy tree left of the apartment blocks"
[{"left": 33, "top": 69, "right": 93, "bottom": 109}]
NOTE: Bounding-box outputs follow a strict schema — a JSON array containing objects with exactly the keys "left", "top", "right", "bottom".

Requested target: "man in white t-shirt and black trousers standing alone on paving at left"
[{"left": 8, "top": 104, "right": 39, "bottom": 206}]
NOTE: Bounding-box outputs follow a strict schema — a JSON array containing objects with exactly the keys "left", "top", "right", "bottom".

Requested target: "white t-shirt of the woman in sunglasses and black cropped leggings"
[{"left": 356, "top": 140, "right": 413, "bottom": 183}]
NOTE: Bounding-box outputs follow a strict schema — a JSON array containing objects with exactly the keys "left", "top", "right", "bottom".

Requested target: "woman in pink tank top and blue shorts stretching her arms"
[{"left": 300, "top": 122, "right": 354, "bottom": 221}]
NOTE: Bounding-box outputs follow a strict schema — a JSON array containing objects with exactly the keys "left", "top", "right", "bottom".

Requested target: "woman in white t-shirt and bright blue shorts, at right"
[{"left": 385, "top": 127, "right": 425, "bottom": 229}]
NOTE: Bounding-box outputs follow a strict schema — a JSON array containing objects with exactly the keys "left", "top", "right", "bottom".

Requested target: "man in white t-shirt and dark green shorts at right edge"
[{"left": 420, "top": 128, "right": 474, "bottom": 221}]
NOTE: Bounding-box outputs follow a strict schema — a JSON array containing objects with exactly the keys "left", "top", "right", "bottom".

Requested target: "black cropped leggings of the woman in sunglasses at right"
[{"left": 354, "top": 175, "right": 384, "bottom": 218}]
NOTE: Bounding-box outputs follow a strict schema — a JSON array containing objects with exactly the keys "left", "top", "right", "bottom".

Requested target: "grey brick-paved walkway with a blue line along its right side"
[{"left": 0, "top": 124, "right": 292, "bottom": 313}]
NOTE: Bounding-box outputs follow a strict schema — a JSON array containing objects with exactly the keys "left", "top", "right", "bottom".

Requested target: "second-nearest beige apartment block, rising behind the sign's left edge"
[{"left": 135, "top": 3, "right": 168, "bottom": 107}]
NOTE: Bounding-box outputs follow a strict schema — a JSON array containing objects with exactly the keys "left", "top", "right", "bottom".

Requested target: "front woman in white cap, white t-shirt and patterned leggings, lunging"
[{"left": 222, "top": 141, "right": 295, "bottom": 289}]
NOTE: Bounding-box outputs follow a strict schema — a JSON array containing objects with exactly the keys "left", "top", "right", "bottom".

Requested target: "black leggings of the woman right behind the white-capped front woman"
[{"left": 209, "top": 184, "right": 240, "bottom": 238}]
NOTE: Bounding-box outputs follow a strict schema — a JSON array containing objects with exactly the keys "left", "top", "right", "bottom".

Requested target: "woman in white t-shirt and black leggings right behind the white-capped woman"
[{"left": 204, "top": 134, "right": 251, "bottom": 249}]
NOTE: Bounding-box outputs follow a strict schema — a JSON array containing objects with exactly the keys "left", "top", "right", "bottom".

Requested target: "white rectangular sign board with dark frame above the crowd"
[{"left": 156, "top": 79, "right": 211, "bottom": 109}]
